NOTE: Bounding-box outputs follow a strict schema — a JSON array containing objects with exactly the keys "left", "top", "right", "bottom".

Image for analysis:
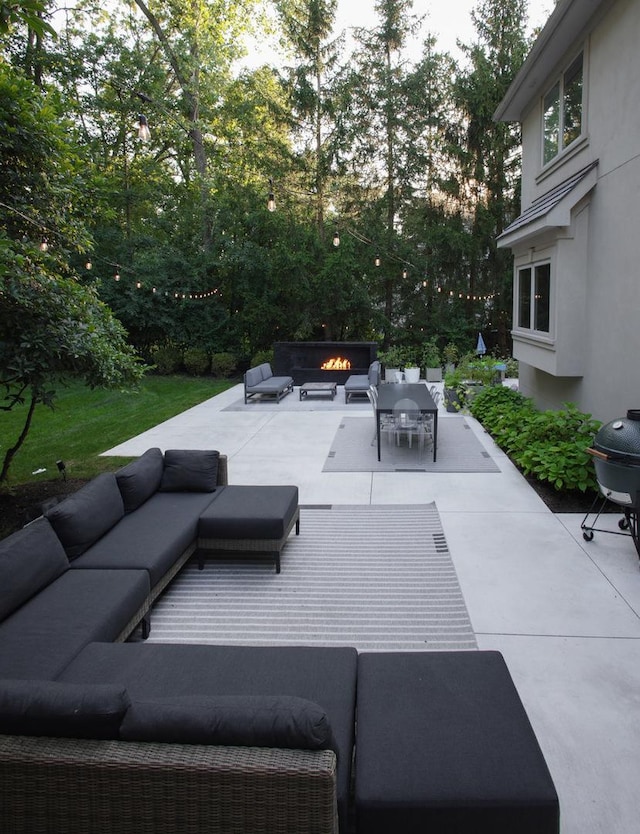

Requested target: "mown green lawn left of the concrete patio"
[{"left": 0, "top": 376, "right": 236, "bottom": 487}]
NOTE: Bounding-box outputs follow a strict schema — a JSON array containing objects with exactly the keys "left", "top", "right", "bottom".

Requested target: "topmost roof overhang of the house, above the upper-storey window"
[{"left": 493, "top": 0, "right": 615, "bottom": 122}]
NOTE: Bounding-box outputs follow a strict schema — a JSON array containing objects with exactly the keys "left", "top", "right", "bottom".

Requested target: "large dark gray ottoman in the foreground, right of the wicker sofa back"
[{"left": 355, "top": 651, "right": 560, "bottom": 834}]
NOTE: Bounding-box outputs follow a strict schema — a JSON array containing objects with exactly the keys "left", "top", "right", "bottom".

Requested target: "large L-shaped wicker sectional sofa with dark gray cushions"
[{"left": 0, "top": 449, "right": 558, "bottom": 834}]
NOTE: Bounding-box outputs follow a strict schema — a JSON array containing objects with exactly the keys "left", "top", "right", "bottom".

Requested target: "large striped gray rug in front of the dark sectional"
[{"left": 144, "top": 504, "right": 477, "bottom": 651}]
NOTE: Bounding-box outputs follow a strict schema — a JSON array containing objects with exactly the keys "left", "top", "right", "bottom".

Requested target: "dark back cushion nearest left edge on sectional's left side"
[{"left": 0, "top": 518, "right": 69, "bottom": 620}]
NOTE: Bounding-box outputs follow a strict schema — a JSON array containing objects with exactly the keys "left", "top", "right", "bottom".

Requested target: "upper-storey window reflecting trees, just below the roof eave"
[{"left": 542, "top": 52, "right": 583, "bottom": 165}]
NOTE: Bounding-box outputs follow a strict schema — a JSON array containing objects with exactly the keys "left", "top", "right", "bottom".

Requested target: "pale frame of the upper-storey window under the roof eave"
[{"left": 540, "top": 47, "right": 587, "bottom": 168}]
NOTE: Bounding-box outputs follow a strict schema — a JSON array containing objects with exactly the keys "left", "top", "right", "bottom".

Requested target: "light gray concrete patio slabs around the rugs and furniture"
[{"left": 105, "top": 386, "right": 640, "bottom": 834}]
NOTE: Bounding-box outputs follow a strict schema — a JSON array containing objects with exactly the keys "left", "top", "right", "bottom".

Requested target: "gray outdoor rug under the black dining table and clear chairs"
[{"left": 322, "top": 415, "right": 500, "bottom": 472}]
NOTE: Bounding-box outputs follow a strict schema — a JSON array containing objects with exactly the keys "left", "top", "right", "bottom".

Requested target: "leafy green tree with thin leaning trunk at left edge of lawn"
[{"left": 0, "top": 64, "right": 144, "bottom": 483}]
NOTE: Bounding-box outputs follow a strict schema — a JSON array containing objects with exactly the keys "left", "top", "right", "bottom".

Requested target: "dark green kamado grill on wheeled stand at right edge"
[{"left": 581, "top": 408, "right": 640, "bottom": 557}]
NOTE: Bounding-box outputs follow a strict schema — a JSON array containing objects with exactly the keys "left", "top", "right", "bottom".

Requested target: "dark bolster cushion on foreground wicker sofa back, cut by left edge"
[{"left": 0, "top": 680, "right": 129, "bottom": 739}]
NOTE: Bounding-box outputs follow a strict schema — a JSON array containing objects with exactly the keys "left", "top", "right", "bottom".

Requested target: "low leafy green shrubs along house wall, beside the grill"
[{"left": 471, "top": 386, "right": 601, "bottom": 492}]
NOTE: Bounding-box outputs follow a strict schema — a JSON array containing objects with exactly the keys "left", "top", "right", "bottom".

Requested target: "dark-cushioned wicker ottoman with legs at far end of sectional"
[{"left": 198, "top": 485, "right": 300, "bottom": 573}]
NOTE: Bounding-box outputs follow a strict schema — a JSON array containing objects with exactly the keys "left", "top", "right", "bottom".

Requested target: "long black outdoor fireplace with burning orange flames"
[{"left": 273, "top": 342, "right": 378, "bottom": 385}]
